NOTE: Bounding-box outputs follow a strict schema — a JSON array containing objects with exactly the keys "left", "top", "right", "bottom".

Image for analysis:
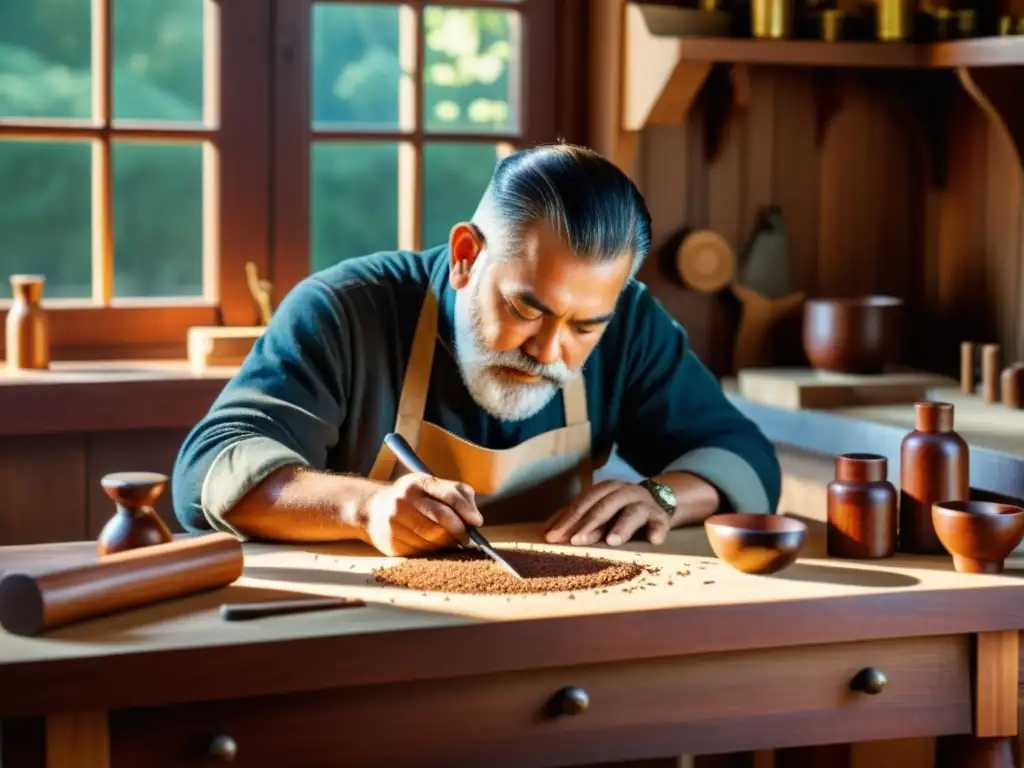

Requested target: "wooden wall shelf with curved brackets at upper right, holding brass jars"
[{"left": 592, "top": 0, "right": 1024, "bottom": 183}]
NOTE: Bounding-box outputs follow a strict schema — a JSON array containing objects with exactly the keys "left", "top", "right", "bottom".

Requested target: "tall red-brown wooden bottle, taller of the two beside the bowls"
[{"left": 899, "top": 402, "right": 971, "bottom": 555}]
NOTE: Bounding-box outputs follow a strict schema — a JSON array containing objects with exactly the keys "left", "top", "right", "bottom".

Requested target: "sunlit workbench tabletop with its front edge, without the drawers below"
[{"left": 0, "top": 505, "right": 1024, "bottom": 715}]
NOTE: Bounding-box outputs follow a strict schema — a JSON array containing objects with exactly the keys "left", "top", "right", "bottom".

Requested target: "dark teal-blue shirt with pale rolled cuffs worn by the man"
[{"left": 172, "top": 246, "right": 780, "bottom": 536}]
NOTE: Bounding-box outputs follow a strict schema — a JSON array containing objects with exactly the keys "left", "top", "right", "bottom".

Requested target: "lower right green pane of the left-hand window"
[{"left": 112, "top": 141, "right": 203, "bottom": 297}]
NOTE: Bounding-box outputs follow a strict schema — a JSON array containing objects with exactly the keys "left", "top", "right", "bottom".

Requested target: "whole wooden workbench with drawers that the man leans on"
[{"left": 0, "top": 444, "right": 1024, "bottom": 768}]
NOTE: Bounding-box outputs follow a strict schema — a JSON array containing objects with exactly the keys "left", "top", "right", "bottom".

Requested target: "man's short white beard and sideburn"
[{"left": 455, "top": 264, "right": 580, "bottom": 421}]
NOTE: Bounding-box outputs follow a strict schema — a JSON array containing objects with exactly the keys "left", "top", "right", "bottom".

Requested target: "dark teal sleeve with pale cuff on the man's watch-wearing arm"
[{"left": 615, "top": 290, "right": 781, "bottom": 513}]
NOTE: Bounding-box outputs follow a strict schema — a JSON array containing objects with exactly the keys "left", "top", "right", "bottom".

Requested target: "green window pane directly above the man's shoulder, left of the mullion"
[{"left": 310, "top": 141, "right": 398, "bottom": 271}]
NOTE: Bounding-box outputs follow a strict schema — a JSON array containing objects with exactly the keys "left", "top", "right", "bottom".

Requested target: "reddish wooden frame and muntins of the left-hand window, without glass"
[{"left": 0, "top": 0, "right": 271, "bottom": 359}]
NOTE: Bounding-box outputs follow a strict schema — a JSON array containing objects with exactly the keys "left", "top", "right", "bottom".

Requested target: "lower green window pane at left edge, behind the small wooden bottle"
[{"left": 0, "top": 141, "right": 92, "bottom": 299}]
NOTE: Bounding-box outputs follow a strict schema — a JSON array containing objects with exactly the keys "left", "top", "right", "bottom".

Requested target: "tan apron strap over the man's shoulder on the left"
[{"left": 368, "top": 288, "right": 437, "bottom": 481}]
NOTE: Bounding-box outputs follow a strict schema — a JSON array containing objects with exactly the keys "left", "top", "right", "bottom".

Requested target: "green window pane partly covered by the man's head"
[{"left": 423, "top": 142, "right": 498, "bottom": 248}]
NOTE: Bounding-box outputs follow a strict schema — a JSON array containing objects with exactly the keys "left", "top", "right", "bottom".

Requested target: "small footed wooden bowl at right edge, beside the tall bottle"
[{"left": 932, "top": 502, "right": 1024, "bottom": 573}]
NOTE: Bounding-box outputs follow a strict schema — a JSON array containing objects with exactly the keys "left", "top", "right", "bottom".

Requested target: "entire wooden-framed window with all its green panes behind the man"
[{"left": 0, "top": 0, "right": 556, "bottom": 358}]
